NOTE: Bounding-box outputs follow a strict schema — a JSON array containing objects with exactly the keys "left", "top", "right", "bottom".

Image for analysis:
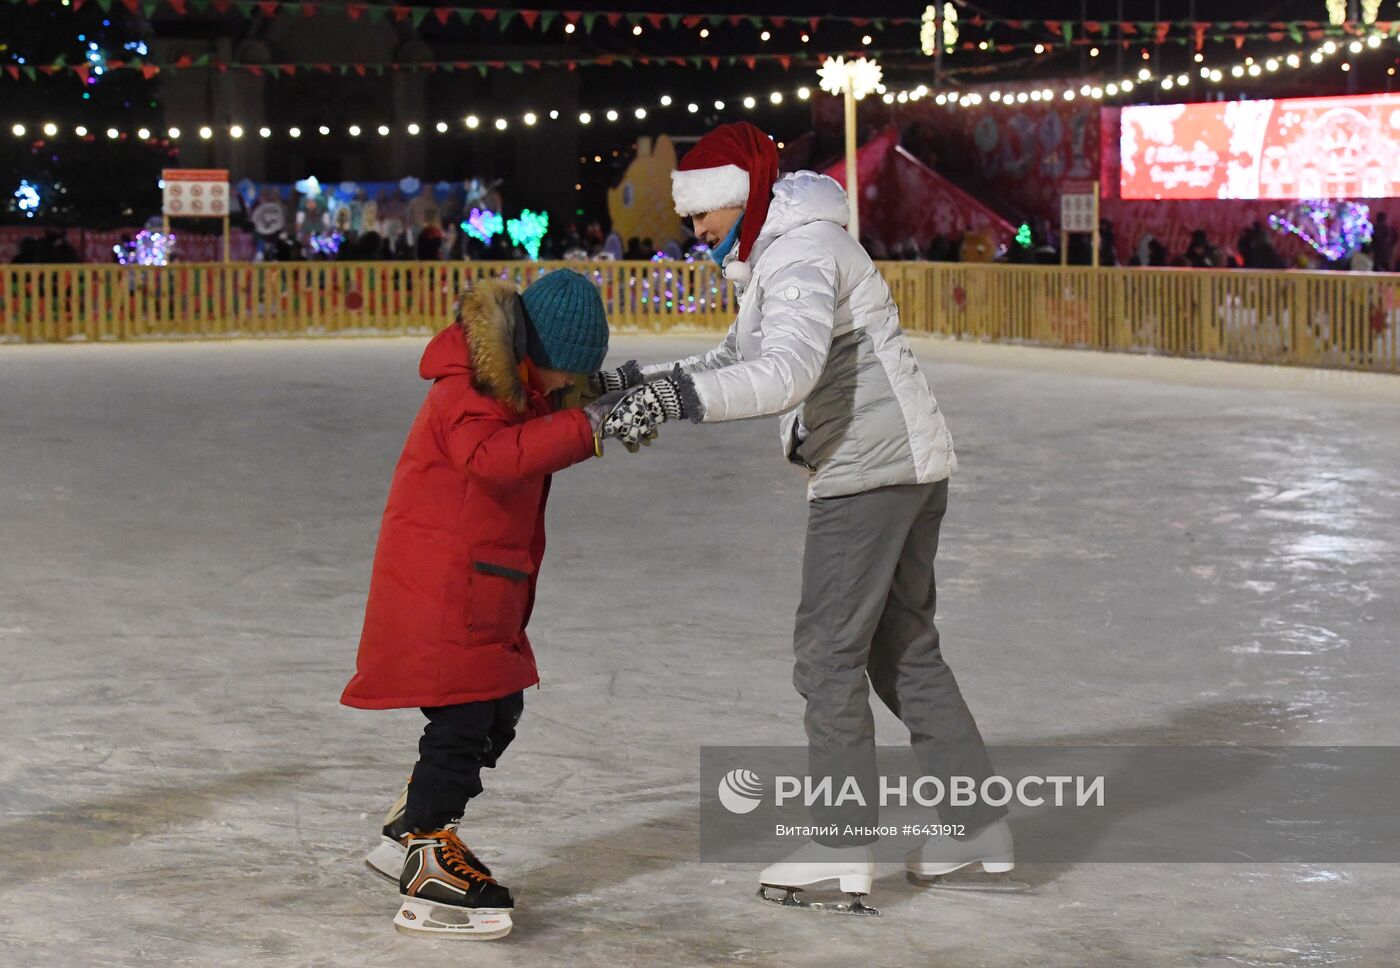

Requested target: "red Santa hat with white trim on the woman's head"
[{"left": 671, "top": 120, "right": 778, "bottom": 283}]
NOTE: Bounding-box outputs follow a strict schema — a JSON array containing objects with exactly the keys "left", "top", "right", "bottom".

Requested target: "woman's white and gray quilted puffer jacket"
[{"left": 644, "top": 171, "right": 958, "bottom": 499}]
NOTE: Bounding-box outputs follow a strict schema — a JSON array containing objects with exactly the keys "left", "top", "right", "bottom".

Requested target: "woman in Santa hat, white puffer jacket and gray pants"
[{"left": 595, "top": 122, "right": 1012, "bottom": 894}]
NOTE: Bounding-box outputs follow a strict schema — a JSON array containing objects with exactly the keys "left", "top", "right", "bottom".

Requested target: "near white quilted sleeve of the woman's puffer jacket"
[{"left": 693, "top": 241, "right": 837, "bottom": 423}]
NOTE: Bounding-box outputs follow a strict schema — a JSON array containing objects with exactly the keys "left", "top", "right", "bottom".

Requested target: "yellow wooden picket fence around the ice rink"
[{"left": 0, "top": 262, "right": 1400, "bottom": 373}]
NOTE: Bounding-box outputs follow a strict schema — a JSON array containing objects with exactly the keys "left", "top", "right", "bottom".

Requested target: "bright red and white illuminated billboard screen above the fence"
[{"left": 1120, "top": 94, "right": 1400, "bottom": 199}]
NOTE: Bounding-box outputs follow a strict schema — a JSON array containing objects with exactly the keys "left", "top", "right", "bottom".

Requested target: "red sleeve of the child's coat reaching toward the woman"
[{"left": 447, "top": 408, "right": 594, "bottom": 490}]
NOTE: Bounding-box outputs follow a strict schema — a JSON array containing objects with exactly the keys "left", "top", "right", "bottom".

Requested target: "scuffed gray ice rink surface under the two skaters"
[{"left": 0, "top": 336, "right": 1400, "bottom": 968}]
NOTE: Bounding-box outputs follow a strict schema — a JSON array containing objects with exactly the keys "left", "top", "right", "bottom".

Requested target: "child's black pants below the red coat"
[{"left": 403, "top": 692, "right": 525, "bottom": 832}]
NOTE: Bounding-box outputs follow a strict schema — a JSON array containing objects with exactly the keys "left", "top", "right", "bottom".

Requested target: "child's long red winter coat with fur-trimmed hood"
[{"left": 340, "top": 282, "right": 594, "bottom": 709}]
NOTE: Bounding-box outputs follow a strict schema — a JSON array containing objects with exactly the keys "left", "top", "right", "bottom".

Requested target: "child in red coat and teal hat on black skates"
[{"left": 340, "top": 269, "right": 612, "bottom": 939}]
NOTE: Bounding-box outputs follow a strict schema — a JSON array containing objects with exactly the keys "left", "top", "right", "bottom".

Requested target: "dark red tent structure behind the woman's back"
[{"left": 826, "top": 126, "right": 1016, "bottom": 255}]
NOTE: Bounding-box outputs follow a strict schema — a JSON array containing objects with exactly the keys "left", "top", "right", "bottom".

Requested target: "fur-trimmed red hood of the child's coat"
[{"left": 419, "top": 279, "right": 528, "bottom": 413}]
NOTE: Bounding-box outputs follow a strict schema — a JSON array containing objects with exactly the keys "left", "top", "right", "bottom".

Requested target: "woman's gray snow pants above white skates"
[{"left": 792, "top": 480, "right": 1007, "bottom": 846}]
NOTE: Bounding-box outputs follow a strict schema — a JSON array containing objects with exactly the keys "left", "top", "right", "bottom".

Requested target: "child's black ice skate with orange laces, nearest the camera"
[{"left": 393, "top": 829, "right": 515, "bottom": 941}]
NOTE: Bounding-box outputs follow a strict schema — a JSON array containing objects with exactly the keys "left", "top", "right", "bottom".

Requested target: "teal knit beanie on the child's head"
[{"left": 521, "top": 269, "right": 608, "bottom": 373}]
